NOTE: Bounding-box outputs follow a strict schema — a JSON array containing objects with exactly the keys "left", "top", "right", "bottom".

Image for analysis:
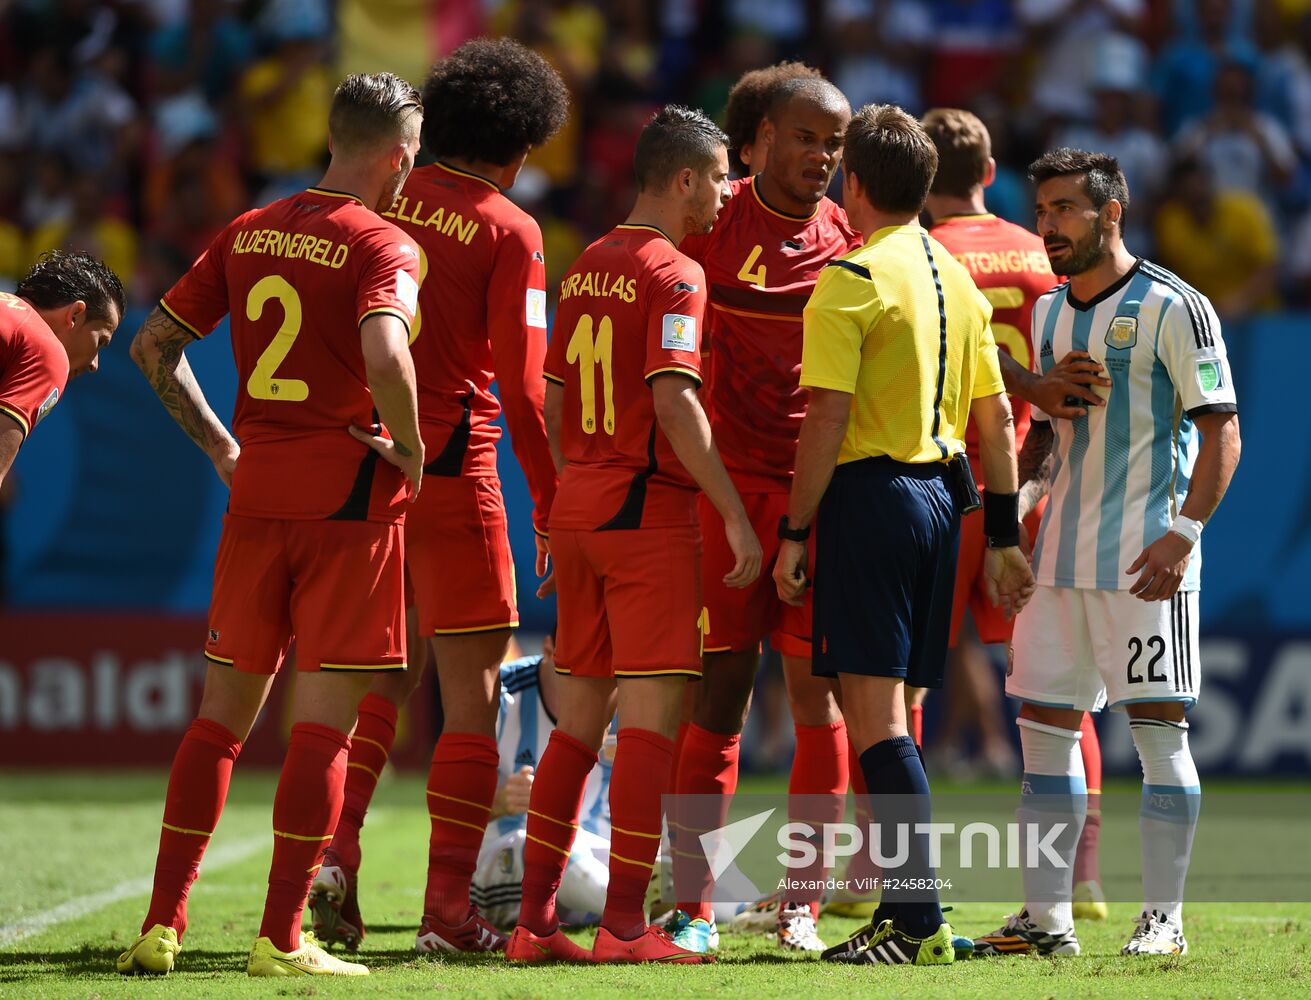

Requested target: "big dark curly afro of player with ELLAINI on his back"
[{"left": 422, "top": 38, "right": 569, "bottom": 165}]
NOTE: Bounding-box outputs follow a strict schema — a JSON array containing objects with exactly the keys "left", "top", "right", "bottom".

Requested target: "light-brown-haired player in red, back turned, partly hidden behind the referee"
[{"left": 912, "top": 107, "right": 1106, "bottom": 920}]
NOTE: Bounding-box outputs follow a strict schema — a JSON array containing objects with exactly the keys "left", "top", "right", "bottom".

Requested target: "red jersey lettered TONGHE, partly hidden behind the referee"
[{"left": 929, "top": 215, "right": 1057, "bottom": 466}]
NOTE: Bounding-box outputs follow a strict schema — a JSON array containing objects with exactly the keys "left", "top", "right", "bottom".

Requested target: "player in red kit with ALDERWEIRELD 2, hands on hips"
[{"left": 118, "top": 73, "right": 423, "bottom": 976}]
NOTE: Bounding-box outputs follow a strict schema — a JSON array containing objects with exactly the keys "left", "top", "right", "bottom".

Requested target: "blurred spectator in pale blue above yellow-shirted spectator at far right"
[{"left": 1173, "top": 60, "right": 1297, "bottom": 201}]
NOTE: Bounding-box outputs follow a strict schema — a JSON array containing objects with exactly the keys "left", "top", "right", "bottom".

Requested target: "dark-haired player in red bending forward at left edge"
[{"left": 0, "top": 250, "right": 123, "bottom": 482}]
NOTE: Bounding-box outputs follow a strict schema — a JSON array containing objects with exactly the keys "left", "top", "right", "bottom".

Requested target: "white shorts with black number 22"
[{"left": 1006, "top": 585, "right": 1202, "bottom": 712}]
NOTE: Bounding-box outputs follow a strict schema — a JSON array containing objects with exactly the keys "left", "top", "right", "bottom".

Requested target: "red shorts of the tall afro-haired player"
[{"left": 405, "top": 476, "right": 519, "bottom": 636}]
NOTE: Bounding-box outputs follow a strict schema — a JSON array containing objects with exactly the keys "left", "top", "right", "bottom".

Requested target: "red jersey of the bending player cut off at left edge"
[{"left": 0, "top": 292, "right": 68, "bottom": 440}]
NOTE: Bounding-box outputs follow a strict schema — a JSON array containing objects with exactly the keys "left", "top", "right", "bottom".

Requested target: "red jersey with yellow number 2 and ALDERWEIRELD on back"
[{"left": 160, "top": 187, "right": 418, "bottom": 520}]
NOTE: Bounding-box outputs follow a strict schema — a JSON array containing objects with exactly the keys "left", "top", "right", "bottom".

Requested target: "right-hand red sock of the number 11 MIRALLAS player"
[{"left": 600, "top": 729, "right": 671, "bottom": 941}]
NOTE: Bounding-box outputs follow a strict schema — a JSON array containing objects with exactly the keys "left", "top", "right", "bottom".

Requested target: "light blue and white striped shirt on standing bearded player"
[{"left": 1032, "top": 260, "right": 1238, "bottom": 591}]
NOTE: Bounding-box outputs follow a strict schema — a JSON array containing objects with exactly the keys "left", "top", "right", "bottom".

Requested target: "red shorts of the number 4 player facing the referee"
[{"left": 697, "top": 493, "right": 815, "bottom": 658}]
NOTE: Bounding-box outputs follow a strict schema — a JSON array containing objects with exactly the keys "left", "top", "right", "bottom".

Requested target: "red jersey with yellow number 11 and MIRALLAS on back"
[{"left": 545, "top": 225, "right": 705, "bottom": 531}]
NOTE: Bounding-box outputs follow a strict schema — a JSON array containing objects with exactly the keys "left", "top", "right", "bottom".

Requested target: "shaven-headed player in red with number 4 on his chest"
[{"left": 673, "top": 75, "right": 861, "bottom": 952}]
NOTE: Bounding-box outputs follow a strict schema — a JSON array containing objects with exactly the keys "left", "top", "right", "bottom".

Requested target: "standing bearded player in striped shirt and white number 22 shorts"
[{"left": 975, "top": 149, "right": 1240, "bottom": 954}]
